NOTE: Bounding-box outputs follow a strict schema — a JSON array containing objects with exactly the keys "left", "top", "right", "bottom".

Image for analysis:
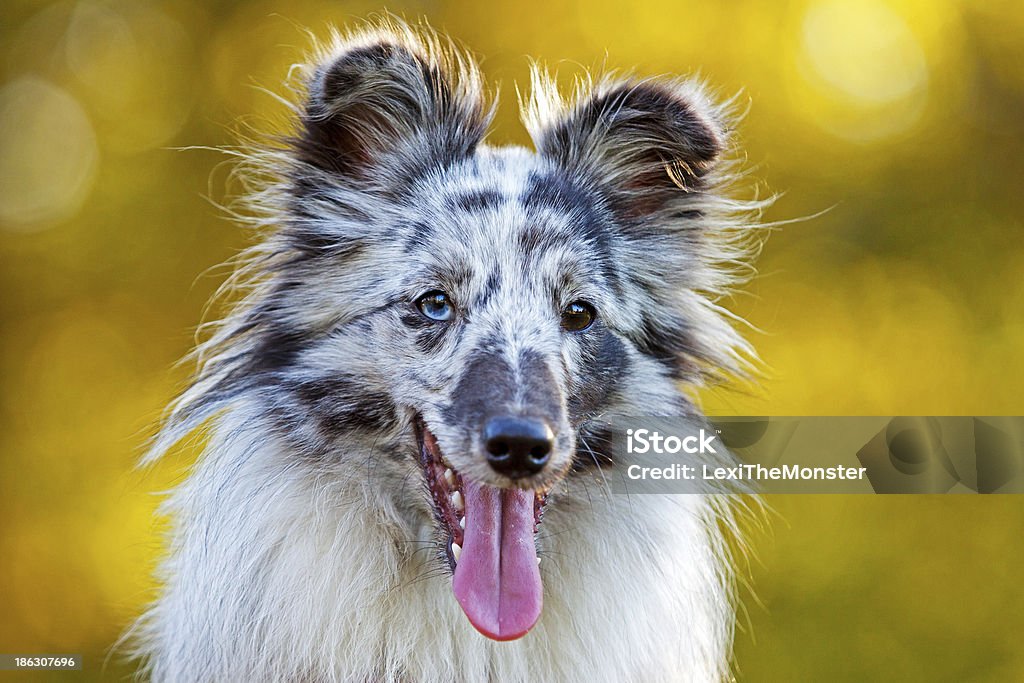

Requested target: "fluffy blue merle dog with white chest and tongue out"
[{"left": 131, "top": 19, "right": 757, "bottom": 683}]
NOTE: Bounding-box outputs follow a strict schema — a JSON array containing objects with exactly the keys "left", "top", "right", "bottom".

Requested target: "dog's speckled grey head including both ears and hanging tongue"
[{"left": 195, "top": 32, "right": 741, "bottom": 640}]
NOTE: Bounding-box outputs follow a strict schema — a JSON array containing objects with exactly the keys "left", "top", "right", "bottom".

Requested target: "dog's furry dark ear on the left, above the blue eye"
[{"left": 296, "top": 27, "right": 492, "bottom": 185}]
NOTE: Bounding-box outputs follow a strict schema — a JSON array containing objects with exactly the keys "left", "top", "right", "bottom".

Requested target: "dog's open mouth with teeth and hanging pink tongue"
[{"left": 416, "top": 420, "right": 546, "bottom": 640}]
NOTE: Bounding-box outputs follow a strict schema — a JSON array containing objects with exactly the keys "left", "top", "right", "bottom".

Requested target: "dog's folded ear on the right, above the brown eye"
[{"left": 526, "top": 74, "right": 725, "bottom": 214}]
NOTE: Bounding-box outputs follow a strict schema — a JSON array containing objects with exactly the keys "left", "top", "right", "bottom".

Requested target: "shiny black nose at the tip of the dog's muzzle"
[{"left": 483, "top": 417, "right": 555, "bottom": 479}]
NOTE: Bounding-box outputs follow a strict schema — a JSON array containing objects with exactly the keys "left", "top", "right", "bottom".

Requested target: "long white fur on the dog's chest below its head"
[{"left": 144, "top": 409, "right": 731, "bottom": 683}]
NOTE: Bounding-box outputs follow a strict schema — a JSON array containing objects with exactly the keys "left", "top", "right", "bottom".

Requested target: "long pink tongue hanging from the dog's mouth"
[{"left": 452, "top": 481, "right": 543, "bottom": 640}]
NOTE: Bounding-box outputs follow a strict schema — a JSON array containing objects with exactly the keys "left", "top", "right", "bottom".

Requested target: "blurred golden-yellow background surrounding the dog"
[{"left": 0, "top": 0, "right": 1024, "bottom": 681}]
